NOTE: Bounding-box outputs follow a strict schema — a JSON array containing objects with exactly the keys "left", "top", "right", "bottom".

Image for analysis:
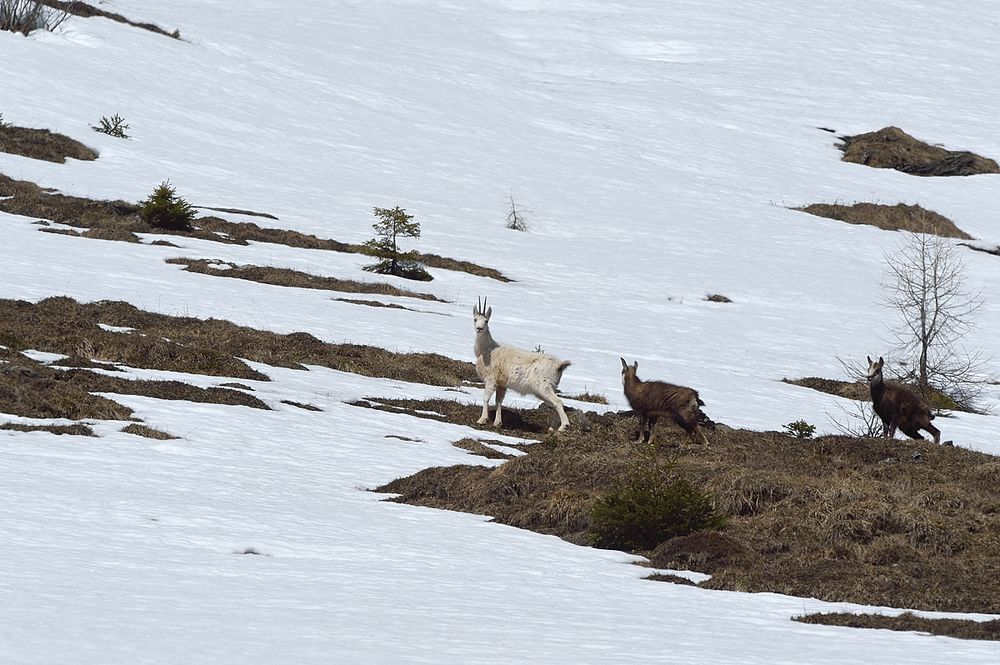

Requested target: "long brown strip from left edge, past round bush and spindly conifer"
[{"left": 0, "top": 173, "right": 512, "bottom": 282}]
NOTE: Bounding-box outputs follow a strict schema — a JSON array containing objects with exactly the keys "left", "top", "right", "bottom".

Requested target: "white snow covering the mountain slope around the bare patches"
[{"left": 0, "top": 0, "right": 1000, "bottom": 665}]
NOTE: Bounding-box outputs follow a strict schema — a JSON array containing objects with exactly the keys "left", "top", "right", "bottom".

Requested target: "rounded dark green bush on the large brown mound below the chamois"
[{"left": 590, "top": 456, "right": 726, "bottom": 551}]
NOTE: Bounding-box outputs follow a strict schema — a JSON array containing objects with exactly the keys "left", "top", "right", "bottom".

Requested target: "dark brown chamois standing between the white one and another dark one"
[{"left": 621, "top": 358, "right": 708, "bottom": 445}]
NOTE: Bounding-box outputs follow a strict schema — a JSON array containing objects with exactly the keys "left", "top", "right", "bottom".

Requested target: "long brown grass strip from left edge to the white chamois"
[{"left": 0, "top": 297, "right": 478, "bottom": 386}]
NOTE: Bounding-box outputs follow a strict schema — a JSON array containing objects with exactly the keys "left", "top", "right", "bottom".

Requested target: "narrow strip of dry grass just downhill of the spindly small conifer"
[{"left": 167, "top": 258, "right": 444, "bottom": 304}]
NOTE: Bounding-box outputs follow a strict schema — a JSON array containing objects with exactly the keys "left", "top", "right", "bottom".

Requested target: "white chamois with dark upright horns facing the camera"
[{"left": 472, "top": 300, "right": 570, "bottom": 432}]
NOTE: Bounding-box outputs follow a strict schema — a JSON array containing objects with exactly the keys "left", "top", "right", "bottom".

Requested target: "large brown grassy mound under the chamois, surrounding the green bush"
[{"left": 379, "top": 401, "right": 1000, "bottom": 613}]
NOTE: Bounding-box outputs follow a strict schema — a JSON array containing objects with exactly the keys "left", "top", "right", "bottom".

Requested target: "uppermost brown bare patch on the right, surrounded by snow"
[{"left": 837, "top": 127, "right": 1000, "bottom": 176}]
